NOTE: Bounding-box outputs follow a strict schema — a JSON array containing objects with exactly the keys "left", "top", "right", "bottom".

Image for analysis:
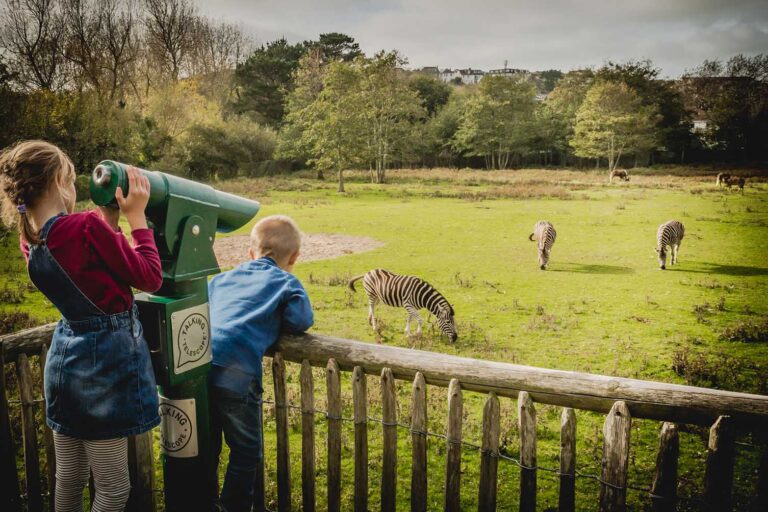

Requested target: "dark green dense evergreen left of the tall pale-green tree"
[{"left": 231, "top": 39, "right": 306, "bottom": 126}]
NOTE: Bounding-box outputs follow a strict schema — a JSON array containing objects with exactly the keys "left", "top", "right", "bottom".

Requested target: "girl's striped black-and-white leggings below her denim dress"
[{"left": 53, "top": 432, "right": 131, "bottom": 512}]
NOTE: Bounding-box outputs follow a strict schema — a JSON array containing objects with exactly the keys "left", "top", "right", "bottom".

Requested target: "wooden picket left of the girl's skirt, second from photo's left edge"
[{"left": 16, "top": 354, "right": 43, "bottom": 512}]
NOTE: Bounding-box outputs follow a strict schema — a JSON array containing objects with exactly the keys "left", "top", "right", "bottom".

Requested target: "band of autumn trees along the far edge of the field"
[{"left": 0, "top": 0, "right": 768, "bottom": 184}]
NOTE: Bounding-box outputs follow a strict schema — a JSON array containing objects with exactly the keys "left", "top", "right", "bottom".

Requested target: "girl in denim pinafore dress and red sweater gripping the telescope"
[{"left": 0, "top": 140, "right": 162, "bottom": 512}]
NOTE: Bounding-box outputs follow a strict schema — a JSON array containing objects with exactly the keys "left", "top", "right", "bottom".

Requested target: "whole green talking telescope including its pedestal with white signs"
[{"left": 90, "top": 160, "right": 259, "bottom": 512}]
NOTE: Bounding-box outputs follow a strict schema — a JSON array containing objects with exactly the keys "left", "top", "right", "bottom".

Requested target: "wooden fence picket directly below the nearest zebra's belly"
[{"left": 381, "top": 368, "right": 397, "bottom": 512}]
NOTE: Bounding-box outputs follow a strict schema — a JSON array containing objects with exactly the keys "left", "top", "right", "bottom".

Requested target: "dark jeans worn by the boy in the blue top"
[{"left": 209, "top": 380, "right": 264, "bottom": 512}]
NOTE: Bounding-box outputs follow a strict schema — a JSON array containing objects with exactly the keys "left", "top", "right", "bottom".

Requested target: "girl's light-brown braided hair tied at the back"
[{"left": 0, "top": 140, "right": 75, "bottom": 245}]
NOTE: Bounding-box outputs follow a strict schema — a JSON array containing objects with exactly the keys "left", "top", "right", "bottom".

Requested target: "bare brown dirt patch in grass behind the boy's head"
[{"left": 213, "top": 233, "right": 384, "bottom": 268}]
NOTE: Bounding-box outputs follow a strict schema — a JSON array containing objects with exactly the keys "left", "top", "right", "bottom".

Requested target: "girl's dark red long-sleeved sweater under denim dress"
[{"left": 21, "top": 211, "right": 163, "bottom": 315}]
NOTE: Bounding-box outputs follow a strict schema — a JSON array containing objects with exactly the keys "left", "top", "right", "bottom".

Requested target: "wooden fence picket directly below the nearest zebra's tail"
[{"left": 352, "top": 366, "right": 368, "bottom": 512}]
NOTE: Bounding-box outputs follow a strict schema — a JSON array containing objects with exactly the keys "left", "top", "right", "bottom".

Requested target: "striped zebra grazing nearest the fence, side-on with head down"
[{"left": 348, "top": 268, "right": 459, "bottom": 343}]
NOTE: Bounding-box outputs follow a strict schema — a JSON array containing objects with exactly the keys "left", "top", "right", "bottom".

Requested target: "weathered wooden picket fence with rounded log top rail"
[{"left": 0, "top": 326, "right": 768, "bottom": 511}]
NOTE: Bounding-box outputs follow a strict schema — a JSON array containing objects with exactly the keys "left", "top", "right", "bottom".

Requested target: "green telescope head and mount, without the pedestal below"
[{"left": 90, "top": 160, "right": 259, "bottom": 281}]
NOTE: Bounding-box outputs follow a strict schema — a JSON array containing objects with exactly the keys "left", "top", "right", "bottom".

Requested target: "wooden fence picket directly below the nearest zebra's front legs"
[{"left": 411, "top": 372, "right": 427, "bottom": 512}]
